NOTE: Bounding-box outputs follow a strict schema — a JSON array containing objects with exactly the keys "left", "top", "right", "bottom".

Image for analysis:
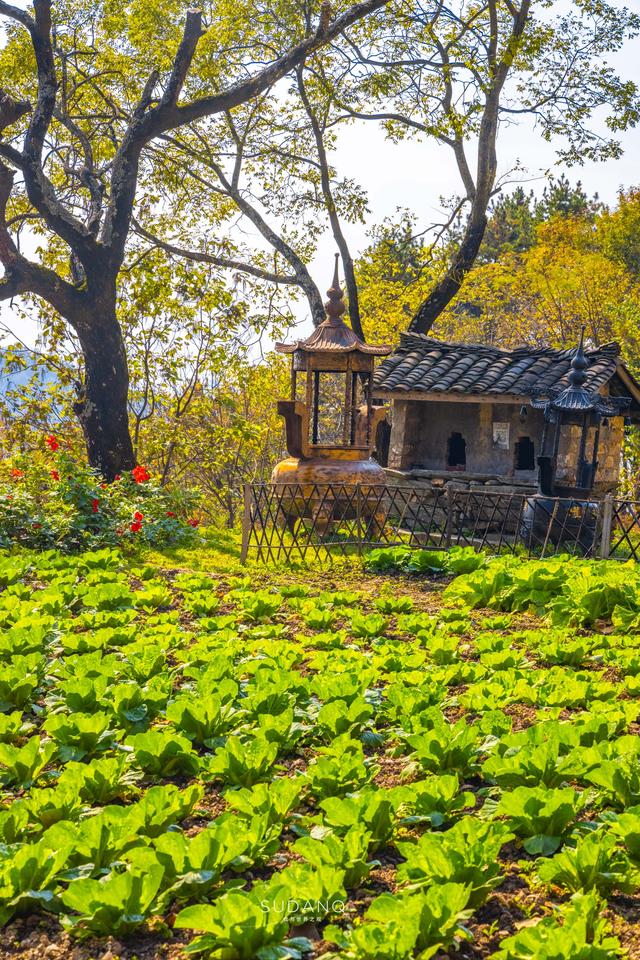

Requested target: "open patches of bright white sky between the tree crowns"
[{"left": 0, "top": 0, "right": 640, "bottom": 342}]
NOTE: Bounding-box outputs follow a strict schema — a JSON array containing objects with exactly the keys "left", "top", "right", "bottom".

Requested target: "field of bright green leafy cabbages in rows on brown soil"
[{"left": 0, "top": 549, "right": 640, "bottom": 960}]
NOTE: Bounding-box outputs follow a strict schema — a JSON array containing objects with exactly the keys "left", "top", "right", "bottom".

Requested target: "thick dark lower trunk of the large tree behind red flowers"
[{"left": 73, "top": 307, "right": 136, "bottom": 481}]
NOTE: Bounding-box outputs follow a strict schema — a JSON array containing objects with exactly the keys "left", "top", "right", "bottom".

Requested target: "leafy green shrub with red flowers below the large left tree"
[{"left": 0, "top": 435, "right": 199, "bottom": 550}]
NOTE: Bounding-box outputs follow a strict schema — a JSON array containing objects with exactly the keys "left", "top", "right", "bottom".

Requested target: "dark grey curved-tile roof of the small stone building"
[{"left": 375, "top": 333, "right": 620, "bottom": 397}]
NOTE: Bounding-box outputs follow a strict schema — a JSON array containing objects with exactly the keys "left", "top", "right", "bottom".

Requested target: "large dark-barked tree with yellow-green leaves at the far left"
[{"left": 0, "top": 0, "right": 385, "bottom": 478}]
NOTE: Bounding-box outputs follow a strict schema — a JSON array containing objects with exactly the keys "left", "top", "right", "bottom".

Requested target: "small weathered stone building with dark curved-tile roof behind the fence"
[{"left": 374, "top": 333, "right": 640, "bottom": 493}]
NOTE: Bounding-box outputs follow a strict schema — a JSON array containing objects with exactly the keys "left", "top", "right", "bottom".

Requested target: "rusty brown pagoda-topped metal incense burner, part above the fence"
[{"left": 271, "top": 255, "right": 391, "bottom": 487}]
